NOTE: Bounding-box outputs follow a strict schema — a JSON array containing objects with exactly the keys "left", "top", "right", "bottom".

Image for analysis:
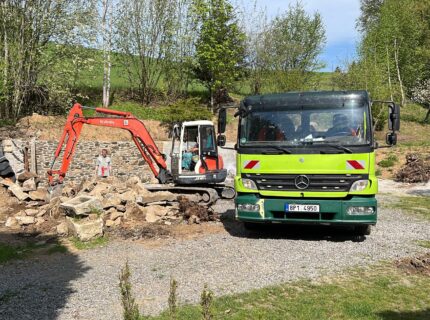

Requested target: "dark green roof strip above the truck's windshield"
[{"left": 243, "top": 90, "right": 369, "bottom": 109}]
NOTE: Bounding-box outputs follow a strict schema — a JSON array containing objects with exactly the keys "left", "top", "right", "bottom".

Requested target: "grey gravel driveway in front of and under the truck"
[{"left": 0, "top": 196, "right": 430, "bottom": 319}]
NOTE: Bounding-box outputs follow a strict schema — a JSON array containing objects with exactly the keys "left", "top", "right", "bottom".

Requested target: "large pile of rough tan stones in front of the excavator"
[{"left": 0, "top": 173, "right": 216, "bottom": 241}]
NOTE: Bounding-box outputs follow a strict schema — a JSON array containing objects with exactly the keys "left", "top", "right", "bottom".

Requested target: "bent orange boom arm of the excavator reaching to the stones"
[{"left": 48, "top": 103, "right": 171, "bottom": 186}]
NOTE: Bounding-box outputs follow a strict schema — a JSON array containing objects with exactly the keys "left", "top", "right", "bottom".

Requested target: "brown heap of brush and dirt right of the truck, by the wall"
[{"left": 396, "top": 153, "right": 430, "bottom": 183}]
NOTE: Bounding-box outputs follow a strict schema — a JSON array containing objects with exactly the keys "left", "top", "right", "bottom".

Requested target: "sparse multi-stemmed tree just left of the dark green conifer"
[{"left": 115, "top": 0, "right": 177, "bottom": 104}]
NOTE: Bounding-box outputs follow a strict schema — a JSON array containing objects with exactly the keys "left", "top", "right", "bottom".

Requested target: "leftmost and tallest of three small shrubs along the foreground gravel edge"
[{"left": 119, "top": 262, "right": 140, "bottom": 320}]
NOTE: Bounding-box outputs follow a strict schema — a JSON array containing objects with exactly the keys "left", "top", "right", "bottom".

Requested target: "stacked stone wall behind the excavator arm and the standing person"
[{"left": 36, "top": 140, "right": 160, "bottom": 182}]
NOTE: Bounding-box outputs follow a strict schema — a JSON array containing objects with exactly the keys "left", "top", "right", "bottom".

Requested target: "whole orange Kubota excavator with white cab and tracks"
[{"left": 48, "top": 103, "right": 235, "bottom": 203}]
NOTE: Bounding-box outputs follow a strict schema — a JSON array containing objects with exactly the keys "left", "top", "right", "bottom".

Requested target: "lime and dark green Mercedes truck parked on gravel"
[{"left": 218, "top": 91, "right": 400, "bottom": 235}]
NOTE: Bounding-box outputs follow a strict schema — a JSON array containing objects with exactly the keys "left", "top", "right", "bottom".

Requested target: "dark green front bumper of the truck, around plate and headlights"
[{"left": 235, "top": 193, "right": 377, "bottom": 225}]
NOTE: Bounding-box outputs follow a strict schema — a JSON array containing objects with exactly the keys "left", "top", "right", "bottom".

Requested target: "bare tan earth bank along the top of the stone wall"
[{"left": 0, "top": 113, "right": 169, "bottom": 142}]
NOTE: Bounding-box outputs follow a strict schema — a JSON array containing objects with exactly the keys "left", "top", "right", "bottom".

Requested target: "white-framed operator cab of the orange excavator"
[{"left": 170, "top": 120, "right": 227, "bottom": 184}]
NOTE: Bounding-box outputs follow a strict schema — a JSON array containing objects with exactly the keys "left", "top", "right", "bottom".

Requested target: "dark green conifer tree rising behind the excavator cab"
[{"left": 193, "top": 0, "right": 246, "bottom": 109}]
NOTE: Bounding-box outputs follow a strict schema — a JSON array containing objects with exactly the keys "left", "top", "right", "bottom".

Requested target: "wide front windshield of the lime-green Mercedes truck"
[{"left": 239, "top": 105, "right": 371, "bottom": 147}]
